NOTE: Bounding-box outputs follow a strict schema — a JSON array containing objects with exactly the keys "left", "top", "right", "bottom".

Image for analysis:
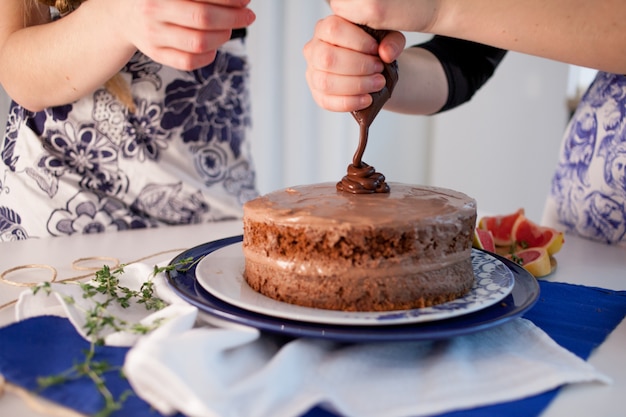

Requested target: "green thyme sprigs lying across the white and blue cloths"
[{"left": 33, "top": 258, "right": 194, "bottom": 417}]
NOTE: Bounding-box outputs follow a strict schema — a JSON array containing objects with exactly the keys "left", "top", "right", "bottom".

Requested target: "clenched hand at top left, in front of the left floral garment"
[{"left": 118, "top": 0, "right": 256, "bottom": 70}]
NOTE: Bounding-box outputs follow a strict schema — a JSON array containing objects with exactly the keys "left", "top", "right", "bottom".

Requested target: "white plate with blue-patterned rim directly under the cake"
[{"left": 196, "top": 242, "right": 515, "bottom": 326}]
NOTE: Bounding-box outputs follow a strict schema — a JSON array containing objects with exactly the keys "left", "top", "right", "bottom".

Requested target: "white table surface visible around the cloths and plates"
[{"left": 0, "top": 221, "right": 626, "bottom": 417}]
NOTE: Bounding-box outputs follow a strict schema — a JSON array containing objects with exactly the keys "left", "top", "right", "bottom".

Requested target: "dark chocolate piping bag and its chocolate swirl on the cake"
[{"left": 337, "top": 25, "right": 398, "bottom": 194}]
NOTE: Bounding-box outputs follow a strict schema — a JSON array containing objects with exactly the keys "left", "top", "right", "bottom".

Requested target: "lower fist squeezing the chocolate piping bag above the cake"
[{"left": 303, "top": 15, "right": 406, "bottom": 112}]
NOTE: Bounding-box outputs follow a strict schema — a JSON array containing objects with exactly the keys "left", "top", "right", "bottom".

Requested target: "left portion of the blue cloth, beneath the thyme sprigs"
[{"left": 0, "top": 316, "right": 182, "bottom": 417}]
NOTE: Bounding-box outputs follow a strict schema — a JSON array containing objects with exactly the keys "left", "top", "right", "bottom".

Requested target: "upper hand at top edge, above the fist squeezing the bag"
[{"left": 329, "top": 0, "right": 439, "bottom": 32}]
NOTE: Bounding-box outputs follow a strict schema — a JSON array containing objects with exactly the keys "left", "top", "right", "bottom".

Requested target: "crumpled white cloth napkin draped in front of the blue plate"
[{"left": 17, "top": 264, "right": 610, "bottom": 417}]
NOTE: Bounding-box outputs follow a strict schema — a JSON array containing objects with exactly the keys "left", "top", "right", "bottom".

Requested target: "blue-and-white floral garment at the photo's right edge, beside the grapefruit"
[{"left": 543, "top": 72, "right": 626, "bottom": 245}]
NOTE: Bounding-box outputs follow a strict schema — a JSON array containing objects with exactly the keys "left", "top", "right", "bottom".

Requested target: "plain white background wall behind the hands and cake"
[{"left": 0, "top": 0, "right": 569, "bottom": 221}]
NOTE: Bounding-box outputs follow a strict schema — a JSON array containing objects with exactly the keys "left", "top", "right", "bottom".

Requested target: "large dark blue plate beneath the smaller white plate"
[{"left": 168, "top": 236, "right": 539, "bottom": 342}]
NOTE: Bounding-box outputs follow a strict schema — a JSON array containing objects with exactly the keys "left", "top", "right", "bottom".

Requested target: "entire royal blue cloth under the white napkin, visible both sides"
[{"left": 0, "top": 281, "right": 626, "bottom": 417}]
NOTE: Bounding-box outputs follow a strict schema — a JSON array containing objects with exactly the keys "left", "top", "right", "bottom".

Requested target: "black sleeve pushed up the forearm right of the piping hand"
[{"left": 414, "top": 35, "right": 506, "bottom": 112}]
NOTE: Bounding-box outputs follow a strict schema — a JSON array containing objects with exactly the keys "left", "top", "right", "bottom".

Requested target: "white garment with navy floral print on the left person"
[{"left": 0, "top": 39, "right": 257, "bottom": 241}]
